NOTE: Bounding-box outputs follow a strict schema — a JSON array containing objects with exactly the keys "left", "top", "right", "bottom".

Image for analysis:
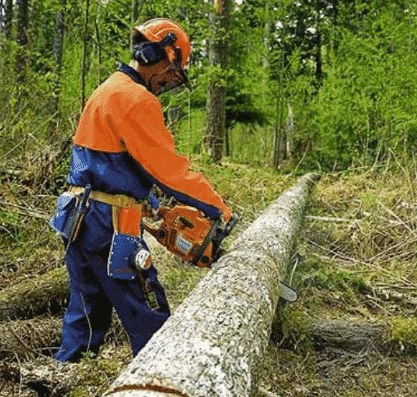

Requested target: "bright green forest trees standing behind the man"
[{"left": 0, "top": 0, "right": 417, "bottom": 173}]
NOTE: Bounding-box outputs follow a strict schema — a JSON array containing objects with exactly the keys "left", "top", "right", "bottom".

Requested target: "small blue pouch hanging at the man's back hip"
[{"left": 49, "top": 192, "right": 81, "bottom": 241}]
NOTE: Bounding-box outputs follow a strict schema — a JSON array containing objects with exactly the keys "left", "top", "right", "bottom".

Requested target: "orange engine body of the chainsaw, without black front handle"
[{"left": 144, "top": 204, "right": 215, "bottom": 267}]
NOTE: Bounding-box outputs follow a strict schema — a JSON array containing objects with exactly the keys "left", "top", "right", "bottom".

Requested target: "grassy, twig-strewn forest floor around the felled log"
[{"left": 0, "top": 161, "right": 417, "bottom": 397}]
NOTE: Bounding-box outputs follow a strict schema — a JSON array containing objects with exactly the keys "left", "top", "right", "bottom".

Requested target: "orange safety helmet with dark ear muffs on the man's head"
[{"left": 132, "top": 18, "right": 191, "bottom": 93}]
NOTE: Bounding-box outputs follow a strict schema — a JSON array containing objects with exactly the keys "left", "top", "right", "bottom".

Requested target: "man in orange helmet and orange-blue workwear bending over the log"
[{"left": 51, "top": 18, "right": 230, "bottom": 362}]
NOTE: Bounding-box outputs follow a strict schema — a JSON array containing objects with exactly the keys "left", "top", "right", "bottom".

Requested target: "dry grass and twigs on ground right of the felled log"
[{"left": 259, "top": 168, "right": 417, "bottom": 397}]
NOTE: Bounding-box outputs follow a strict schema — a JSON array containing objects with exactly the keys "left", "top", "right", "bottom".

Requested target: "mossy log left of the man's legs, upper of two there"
[{"left": 0, "top": 267, "right": 68, "bottom": 322}]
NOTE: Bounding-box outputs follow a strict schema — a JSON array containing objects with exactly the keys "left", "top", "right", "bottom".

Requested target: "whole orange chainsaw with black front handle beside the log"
[{"left": 143, "top": 203, "right": 239, "bottom": 267}]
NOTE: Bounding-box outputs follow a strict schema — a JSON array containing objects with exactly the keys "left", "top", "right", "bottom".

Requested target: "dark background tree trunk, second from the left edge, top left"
[{"left": 16, "top": 0, "right": 29, "bottom": 84}]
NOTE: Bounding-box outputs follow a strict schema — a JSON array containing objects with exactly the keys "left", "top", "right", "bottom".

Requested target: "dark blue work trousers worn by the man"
[{"left": 55, "top": 200, "right": 169, "bottom": 362}]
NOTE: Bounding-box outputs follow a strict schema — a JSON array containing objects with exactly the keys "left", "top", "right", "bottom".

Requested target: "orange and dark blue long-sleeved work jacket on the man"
[{"left": 68, "top": 65, "right": 230, "bottom": 221}]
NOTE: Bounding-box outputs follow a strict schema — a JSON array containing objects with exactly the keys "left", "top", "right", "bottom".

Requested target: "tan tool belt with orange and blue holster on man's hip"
[{"left": 69, "top": 186, "right": 160, "bottom": 310}]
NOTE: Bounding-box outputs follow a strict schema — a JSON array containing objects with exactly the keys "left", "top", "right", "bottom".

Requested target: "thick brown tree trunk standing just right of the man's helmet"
[{"left": 206, "top": 0, "right": 232, "bottom": 163}]
